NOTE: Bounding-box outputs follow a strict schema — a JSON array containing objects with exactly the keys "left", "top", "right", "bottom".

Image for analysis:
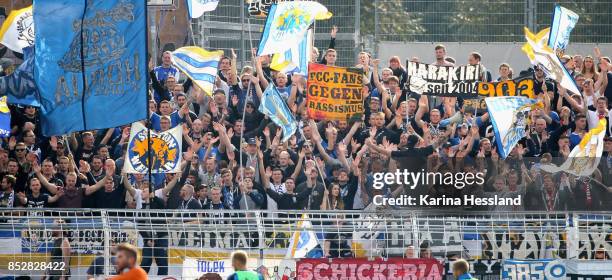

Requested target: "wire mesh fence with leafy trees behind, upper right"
[{"left": 372, "top": 0, "right": 612, "bottom": 43}]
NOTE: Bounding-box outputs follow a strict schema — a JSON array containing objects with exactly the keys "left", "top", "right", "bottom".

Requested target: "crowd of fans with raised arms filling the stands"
[{"left": 0, "top": 26, "right": 612, "bottom": 214}]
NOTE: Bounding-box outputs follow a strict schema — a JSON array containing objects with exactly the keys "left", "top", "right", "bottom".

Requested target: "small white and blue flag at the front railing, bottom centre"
[{"left": 285, "top": 214, "right": 323, "bottom": 259}]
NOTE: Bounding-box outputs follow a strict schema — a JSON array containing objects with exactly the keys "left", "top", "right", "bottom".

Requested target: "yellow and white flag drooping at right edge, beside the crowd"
[{"left": 541, "top": 118, "right": 608, "bottom": 176}]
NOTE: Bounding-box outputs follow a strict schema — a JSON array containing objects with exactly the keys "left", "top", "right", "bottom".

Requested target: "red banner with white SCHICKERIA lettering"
[{"left": 297, "top": 258, "right": 444, "bottom": 280}]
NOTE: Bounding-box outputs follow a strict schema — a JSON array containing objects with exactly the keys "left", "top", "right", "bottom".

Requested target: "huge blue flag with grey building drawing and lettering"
[{"left": 34, "top": 0, "right": 148, "bottom": 136}]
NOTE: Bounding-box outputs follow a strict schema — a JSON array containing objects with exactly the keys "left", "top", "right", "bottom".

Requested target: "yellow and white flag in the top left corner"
[{"left": 0, "top": 6, "right": 35, "bottom": 53}]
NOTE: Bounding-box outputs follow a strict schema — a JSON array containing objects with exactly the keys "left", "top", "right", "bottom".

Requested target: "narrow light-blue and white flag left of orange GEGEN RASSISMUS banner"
[{"left": 259, "top": 83, "right": 297, "bottom": 142}]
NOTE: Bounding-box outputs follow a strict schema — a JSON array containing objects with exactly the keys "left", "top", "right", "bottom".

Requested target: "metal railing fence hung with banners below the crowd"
[{"left": 0, "top": 209, "right": 612, "bottom": 279}]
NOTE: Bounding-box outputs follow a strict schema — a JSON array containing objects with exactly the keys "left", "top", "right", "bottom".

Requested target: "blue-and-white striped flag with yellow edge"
[{"left": 172, "top": 46, "right": 223, "bottom": 95}]
